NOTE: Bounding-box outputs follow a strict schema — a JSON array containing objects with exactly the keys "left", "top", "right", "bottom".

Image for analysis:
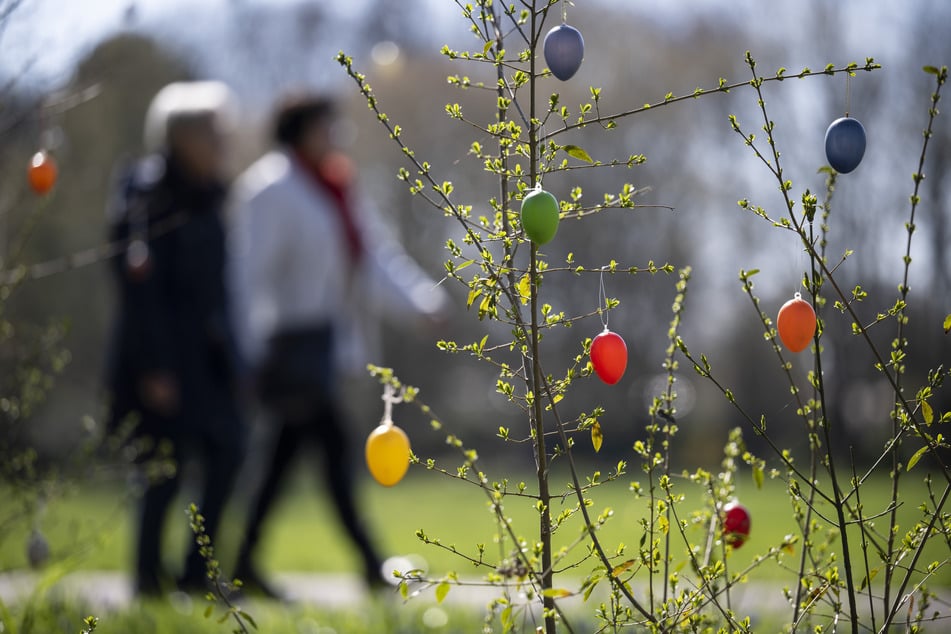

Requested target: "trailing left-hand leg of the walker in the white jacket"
[{"left": 235, "top": 423, "right": 302, "bottom": 585}]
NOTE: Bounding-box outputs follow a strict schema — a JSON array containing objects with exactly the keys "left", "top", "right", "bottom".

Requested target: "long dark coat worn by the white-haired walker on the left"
[{"left": 107, "top": 156, "right": 239, "bottom": 436}]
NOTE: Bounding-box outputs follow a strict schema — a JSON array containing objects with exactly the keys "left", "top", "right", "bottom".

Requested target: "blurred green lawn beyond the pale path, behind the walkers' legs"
[{"left": 0, "top": 460, "right": 951, "bottom": 585}]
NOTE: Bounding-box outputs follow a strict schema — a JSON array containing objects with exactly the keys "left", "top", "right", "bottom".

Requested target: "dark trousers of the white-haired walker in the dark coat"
[{"left": 136, "top": 422, "right": 244, "bottom": 593}]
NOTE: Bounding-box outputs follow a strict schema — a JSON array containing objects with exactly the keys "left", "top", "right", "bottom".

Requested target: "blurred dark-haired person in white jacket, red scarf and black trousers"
[{"left": 230, "top": 95, "right": 446, "bottom": 594}]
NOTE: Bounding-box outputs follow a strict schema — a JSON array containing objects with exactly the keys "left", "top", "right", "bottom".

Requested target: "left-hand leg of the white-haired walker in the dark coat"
[{"left": 135, "top": 434, "right": 181, "bottom": 595}]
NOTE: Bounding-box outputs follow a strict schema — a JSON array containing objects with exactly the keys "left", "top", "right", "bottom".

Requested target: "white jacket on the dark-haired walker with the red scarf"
[{"left": 229, "top": 152, "right": 447, "bottom": 371}]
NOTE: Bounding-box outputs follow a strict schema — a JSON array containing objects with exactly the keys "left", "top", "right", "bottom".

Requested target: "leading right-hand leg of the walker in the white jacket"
[{"left": 314, "top": 405, "right": 383, "bottom": 586}]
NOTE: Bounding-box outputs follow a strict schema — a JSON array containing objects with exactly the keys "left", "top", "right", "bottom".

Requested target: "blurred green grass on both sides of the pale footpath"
[{"left": 0, "top": 460, "right": 951, "bottom": 634}]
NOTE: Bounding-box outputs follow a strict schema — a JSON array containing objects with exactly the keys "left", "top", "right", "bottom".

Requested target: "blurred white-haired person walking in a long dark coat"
[{"left": 108, "top": 82, "right": 245, "bottom": 595}]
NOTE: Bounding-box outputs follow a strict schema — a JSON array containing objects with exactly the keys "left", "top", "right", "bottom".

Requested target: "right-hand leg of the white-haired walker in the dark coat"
[{"left": 182, "top": 414, "right": 245, "bottom": 587}]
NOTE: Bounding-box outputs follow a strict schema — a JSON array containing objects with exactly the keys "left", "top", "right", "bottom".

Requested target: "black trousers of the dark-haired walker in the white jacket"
[{"left": 238, "top": 402, "right": 382, "bottom": 584}]
